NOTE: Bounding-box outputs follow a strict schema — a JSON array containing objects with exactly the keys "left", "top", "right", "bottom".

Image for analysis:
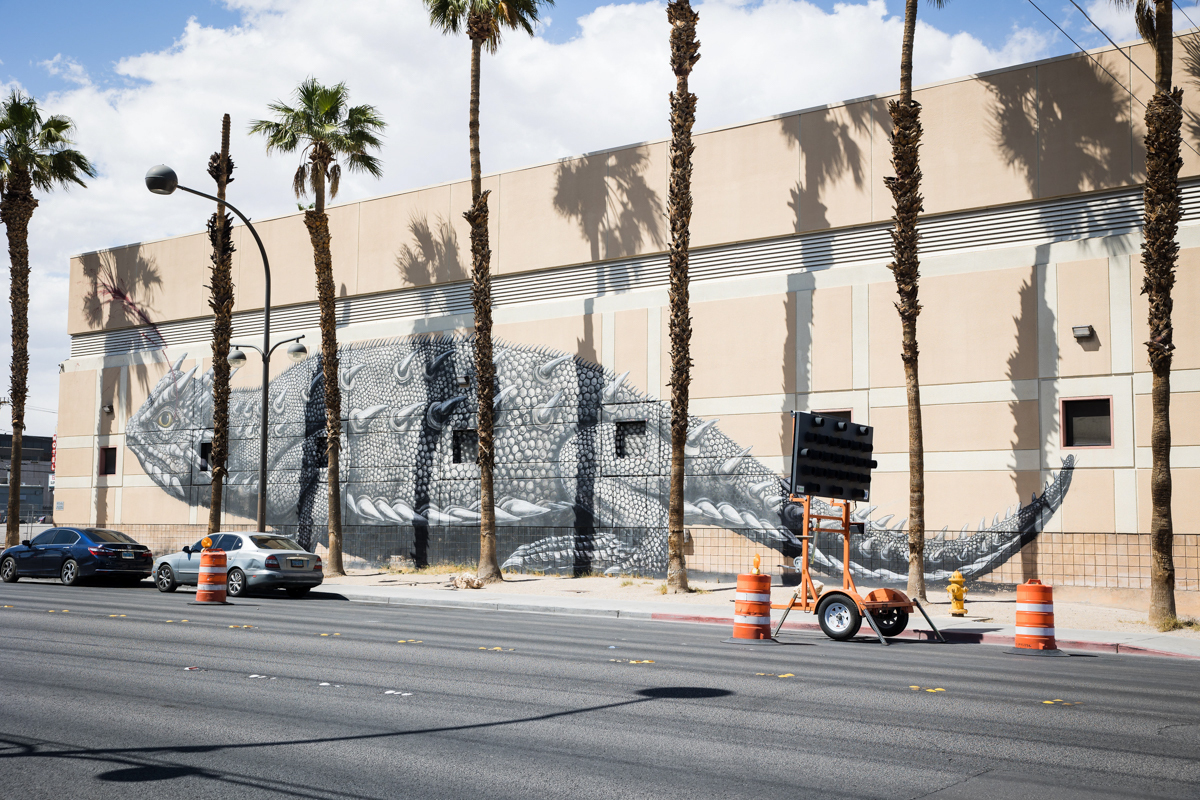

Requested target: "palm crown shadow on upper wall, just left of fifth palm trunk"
[{"left": 553, "top": 148, "right": 666, "bottom": 261}]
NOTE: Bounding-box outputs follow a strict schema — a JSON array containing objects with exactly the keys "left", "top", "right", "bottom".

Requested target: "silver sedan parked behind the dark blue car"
[{"left": 154, "top": 534, "right": 325, "bottom": 597}]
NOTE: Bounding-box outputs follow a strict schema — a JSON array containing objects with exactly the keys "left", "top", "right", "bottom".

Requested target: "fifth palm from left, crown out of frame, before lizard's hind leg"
[{"left": 667, "top": 0, "right": 700, "bottom": 593}]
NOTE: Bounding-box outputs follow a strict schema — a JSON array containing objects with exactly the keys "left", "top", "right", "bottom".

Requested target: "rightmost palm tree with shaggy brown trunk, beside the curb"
[{"left": 1114, "top": 0, "right": 1183, "bottom": 625}]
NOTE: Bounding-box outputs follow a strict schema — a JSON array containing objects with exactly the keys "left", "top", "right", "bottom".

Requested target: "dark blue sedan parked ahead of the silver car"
[{"left": 0, "top": 528, "right": 154, "bottom": 587}]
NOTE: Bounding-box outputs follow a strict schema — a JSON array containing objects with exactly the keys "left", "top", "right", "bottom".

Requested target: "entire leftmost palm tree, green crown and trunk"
[{"left": 0, "top": 90, "right": 96, "bottom": 547}]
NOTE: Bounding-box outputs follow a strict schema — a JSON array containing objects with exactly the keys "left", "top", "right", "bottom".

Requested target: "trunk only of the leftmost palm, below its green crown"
[{"left": 0, "top": 167, "right": 37, "bottom": 547}]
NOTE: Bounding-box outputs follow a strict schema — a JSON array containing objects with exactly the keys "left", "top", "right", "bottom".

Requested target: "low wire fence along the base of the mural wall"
[{"left": 68, "top": 524, "right": 1200, "bottom": 591}]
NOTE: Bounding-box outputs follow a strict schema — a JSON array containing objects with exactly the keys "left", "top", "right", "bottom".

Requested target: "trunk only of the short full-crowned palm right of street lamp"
[{"left": 304, "top": 160, "right": 346, "bottom": 575}]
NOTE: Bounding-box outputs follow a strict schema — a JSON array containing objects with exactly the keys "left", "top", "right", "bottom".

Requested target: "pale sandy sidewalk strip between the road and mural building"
[{"left": 319, "top": 571, "right": 1200, "bottom": 660}]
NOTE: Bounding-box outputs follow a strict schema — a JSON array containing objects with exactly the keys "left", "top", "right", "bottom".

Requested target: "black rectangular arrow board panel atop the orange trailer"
[{"left": 792, "top": 411, "right": 878, "bottom": 500}]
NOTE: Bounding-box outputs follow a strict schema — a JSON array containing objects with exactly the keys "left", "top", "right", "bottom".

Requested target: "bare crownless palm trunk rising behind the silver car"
[{"left": 209, "top": 114, "right": 234, "bottom": 536}]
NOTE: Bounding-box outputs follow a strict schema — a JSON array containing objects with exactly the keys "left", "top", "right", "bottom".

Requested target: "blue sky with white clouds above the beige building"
[{"left": 0, "top": 0, "right": 1200, "bottom": 435}]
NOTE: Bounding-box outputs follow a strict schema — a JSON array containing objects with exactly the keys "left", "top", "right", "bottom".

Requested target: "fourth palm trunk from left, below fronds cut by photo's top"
[{"left": 463, "top": 21, "right": 504, "bottom": 584}]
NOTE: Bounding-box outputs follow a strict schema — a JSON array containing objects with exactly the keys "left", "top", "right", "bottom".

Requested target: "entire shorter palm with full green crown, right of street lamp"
[{"left": 250, "top": 78, "right": 386, "bottom": 575}]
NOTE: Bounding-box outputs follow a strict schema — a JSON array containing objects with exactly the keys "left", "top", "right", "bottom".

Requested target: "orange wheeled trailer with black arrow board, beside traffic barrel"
[{"left": 772, "top": 411, "right": 946, "bottom": 645}]
